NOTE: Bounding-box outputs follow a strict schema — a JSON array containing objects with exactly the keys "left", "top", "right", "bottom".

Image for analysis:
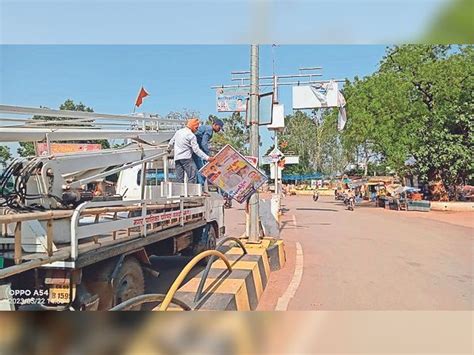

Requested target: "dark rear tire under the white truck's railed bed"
[{"left": 87, "top": 256, "right": 145, "bottom": 311}]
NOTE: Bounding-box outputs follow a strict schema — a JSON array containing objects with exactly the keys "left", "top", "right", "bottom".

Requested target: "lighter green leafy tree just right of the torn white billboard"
[{"left": 342, "top": 73, "right": 412, "bottom": 177}]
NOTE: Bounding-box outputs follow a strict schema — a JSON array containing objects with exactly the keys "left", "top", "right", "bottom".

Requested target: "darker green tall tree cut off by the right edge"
[{"left": 381, "top": 45, "right": 474, "bottom": 197}]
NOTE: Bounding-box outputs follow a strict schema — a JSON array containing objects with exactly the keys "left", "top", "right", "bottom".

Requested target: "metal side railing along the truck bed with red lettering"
[{"left": 0, "top": 196, "right": 206, "bottom": 279}]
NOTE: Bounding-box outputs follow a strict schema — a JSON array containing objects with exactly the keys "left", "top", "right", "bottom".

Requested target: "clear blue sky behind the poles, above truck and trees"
[{"left": 0, "top": 45, "right": 386, "bottom": 156}]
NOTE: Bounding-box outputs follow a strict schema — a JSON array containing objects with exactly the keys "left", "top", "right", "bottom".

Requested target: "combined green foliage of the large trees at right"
[{"left": 342, "top": 45, "right": 474, "bottom": 199}]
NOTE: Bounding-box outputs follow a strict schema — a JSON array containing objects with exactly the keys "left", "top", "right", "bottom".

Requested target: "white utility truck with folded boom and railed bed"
[{"left": 0, "top": 105, "right": 225, "bottom": 310}]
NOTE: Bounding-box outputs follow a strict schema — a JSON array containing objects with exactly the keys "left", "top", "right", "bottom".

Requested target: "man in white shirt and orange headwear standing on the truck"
[{"left": 168, "top": 118, "right": 215, "bottom": 184}]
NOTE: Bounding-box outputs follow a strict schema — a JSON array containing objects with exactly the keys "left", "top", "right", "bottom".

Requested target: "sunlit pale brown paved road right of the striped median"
[{"left": 259, "top": 196, "right": 474, "bottom": 310}]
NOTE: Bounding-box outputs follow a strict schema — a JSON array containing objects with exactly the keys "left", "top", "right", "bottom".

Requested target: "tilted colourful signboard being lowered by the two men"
[{"left": 199, "top": 145, "right": 268, "bottom": 203}]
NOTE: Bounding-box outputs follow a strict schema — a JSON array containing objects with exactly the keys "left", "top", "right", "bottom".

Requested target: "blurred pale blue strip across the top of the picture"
[{"left": 0, "top": 0, "right": 452, "bottom": 44}]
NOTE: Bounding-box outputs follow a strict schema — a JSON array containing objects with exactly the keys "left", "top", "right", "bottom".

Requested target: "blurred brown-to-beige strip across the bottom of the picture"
[{"left": 0, "top": 311, "right": 474, "bottom": 355}]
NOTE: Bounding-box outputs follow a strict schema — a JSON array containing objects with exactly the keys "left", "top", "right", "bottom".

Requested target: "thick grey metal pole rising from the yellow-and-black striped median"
[{"left": 248, "top": 44, "right": 260, "bottom": 243}]
